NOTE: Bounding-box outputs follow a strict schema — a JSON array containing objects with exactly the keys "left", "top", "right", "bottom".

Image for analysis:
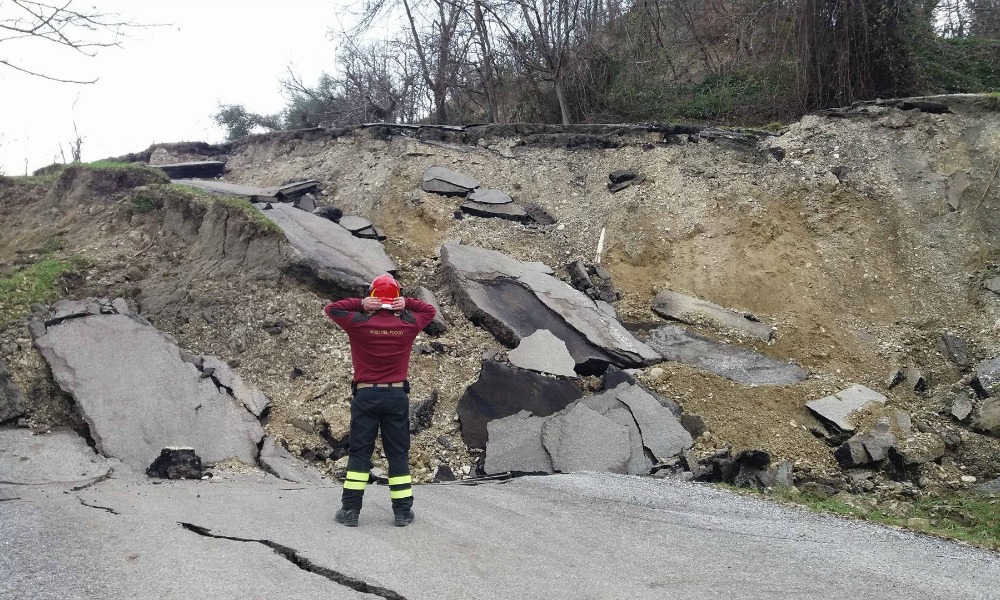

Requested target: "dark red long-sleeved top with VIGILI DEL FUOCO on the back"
[{"left": 323, "top": 298, "right": 437, "bottom": 383}]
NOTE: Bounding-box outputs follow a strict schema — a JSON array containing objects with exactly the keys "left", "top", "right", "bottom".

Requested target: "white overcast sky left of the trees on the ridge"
[{"left": 0, "top": 0, "right": 353, "bottom": 175}]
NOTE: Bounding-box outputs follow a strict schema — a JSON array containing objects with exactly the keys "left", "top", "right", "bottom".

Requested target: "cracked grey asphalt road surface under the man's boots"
[{"left": 0, "top": 473, "right": 1000, "bottom": 600}]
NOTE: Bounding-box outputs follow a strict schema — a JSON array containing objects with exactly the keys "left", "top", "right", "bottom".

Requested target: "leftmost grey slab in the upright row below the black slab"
[{"left": 485, "top": 410, "right": 553, "bottom": 475}]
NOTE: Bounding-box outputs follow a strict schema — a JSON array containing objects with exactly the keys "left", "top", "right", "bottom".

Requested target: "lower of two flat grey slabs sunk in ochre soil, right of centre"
[{"left": 646, "top": 325, "right": 807, "bottom": 385}]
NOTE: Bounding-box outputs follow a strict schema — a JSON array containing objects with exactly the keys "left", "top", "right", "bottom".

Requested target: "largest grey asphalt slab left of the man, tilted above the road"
[{"left": 31, "top": 298, "right": 266, "bottom": 470}]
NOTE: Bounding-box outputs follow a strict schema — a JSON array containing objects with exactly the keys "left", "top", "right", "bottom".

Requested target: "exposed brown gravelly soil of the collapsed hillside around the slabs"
[{"left": 0, "top": 96, "right": 1000, "bottom": 487}]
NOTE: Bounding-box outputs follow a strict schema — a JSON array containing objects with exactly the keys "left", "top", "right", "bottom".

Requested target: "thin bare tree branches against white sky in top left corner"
[{"left": 0, "top": 0, "right": 136, "bottom": 83}]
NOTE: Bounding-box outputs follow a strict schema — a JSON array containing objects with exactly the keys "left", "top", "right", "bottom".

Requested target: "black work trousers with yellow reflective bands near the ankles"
[{"left": 343, "top": 387, "right": 413, "bottom": 510}]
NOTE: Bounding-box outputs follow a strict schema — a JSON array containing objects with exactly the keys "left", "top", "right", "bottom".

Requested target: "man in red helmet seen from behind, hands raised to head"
[{"left": 325, "top": 274, "right": 436, "bottom": 527}]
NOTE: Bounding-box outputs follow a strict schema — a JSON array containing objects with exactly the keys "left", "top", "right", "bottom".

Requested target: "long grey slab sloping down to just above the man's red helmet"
[{"left": 263, "top": 204, "right": 396, "bottom": 297}]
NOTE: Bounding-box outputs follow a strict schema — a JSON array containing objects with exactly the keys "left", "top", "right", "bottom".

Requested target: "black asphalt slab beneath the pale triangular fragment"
[{"left": 457, "top": 360, "right": 580, "bottom": 448}]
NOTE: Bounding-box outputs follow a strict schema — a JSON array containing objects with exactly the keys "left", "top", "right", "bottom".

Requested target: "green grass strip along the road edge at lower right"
[{"left": 766, "top": 490, "right": 1000, "bottom": 550}]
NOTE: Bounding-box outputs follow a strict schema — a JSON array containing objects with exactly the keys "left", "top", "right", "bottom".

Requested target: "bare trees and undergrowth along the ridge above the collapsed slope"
[{"left": 215, "top": 0, "right": 1000, "bottom": 137}]
